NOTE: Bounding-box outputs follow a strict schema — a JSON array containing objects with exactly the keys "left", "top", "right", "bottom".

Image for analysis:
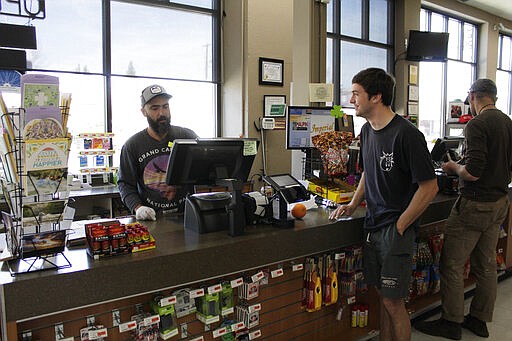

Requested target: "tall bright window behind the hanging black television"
[{"left": 418, "top": 8, "right": 477, "bottom": 142}]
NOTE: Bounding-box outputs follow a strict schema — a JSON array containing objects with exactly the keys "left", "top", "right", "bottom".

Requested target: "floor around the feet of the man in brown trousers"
[{"left": 411, "top": 277, "right": 512, "bottom": 341}]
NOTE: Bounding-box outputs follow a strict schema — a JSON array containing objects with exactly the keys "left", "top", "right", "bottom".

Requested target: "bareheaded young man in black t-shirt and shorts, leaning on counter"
[{"left": 330, "top": 68, "right": 437, "bottom": 341}]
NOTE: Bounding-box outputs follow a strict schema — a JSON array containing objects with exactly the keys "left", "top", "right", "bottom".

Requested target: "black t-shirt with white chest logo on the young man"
[{"left": 361, "top": 115, "right": 435, "bottom": 230}]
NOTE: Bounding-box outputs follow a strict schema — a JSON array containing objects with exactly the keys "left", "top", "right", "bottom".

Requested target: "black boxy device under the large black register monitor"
[{"left": 184, "top": 192, "right": 231, "bottom": 233}]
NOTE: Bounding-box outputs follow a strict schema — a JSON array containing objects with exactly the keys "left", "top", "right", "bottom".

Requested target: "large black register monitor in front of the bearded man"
[{"left": 166, "top": 138, "right": 258, "bottom": 185}]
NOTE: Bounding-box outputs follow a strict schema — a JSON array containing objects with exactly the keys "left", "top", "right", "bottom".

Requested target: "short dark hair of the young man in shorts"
[{"left": 352, "top": 67, "right": 395, "bottom": 106}]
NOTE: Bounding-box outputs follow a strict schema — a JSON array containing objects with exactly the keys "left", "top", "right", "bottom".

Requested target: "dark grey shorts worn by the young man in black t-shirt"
[{"left": 363, "top": 223, "right": 416, "bottom": 298}]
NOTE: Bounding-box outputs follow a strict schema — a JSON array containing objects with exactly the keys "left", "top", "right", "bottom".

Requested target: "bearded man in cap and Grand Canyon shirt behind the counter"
[{"left": 117, "top": 84, "right": 197, "bottom": 220}]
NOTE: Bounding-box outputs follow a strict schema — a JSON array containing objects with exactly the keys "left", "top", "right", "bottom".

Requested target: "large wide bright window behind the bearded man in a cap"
[{"left": 0, "top": 0, "right": 220, "bottom": 174}]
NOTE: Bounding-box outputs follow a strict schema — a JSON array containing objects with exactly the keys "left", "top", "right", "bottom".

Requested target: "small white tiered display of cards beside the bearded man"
[{"left": 77, "top": 133, "right": 117, "bottom": 185}]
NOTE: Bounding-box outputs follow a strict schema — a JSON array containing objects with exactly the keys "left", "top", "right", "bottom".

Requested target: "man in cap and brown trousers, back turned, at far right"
[{"left": 415, "top": 79, "right": 512, "bottom": 340}]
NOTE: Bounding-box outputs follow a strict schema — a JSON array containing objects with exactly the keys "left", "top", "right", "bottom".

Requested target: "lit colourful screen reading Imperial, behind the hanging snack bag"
[{"left": 286, "top": 105, "right": 336, "bottom": 150}]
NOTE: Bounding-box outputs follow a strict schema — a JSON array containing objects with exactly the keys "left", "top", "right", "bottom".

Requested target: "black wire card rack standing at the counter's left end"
[{"left": 0, "top": 103, "right": 73, "bottom": 276}]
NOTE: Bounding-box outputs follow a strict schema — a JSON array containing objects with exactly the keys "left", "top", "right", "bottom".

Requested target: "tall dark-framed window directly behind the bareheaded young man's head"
[{"left": 326, "top": 0, "right": 394, "bottom": 135}]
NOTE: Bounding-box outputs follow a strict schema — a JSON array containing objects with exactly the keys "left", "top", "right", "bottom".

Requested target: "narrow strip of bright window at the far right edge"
[{"left": 496, "top": 33, "right": 512, "bottom": 115}]
